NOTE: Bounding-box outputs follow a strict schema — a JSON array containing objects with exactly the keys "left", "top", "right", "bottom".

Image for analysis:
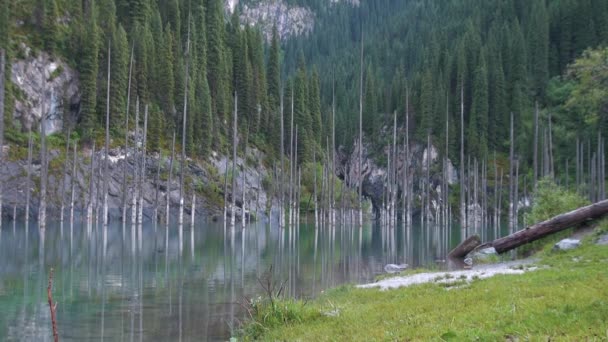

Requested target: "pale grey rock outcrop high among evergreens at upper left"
[{"left": 11, "top": 45, "right": 80, "bottom": 135}]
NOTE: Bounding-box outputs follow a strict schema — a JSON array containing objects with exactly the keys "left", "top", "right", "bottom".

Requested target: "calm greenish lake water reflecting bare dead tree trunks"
[{"left": 0, "top": 218, "right": 476, "bottom": 341}]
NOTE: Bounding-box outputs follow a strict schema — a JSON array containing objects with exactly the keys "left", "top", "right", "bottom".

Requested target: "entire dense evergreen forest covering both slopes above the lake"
[{"left": 0, "top": 0, "right": 608, "bottom": 182}]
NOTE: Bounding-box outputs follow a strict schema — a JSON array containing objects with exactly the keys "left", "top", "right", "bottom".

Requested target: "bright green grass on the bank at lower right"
[{"left": 244, "top": 242, "right": 608, "bottom": 341}]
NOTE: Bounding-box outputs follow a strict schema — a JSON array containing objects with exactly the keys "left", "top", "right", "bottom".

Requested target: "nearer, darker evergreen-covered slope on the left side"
[{"left": 0, "top": 0, "right": 319, "bottom": 158}]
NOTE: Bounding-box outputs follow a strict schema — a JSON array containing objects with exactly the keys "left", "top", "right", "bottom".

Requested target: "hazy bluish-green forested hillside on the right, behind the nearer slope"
[{"left": 285, "top": 0, "right": 608, "bottom": 166}]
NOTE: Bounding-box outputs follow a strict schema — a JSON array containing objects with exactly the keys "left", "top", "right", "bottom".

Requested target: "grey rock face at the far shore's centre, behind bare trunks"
[{"left": 337, "top": 136, "right": 458, "bottom": 220}]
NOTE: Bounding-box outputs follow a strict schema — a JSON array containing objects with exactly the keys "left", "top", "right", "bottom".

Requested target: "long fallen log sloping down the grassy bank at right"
[{"left": 490, "top": 200, "right": 608, "bottom": 254}]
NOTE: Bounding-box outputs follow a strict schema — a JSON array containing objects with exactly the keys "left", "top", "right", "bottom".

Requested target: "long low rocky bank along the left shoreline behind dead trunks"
[{"left": 0, "top": 143, "right": 271, "bottom": 222}]
